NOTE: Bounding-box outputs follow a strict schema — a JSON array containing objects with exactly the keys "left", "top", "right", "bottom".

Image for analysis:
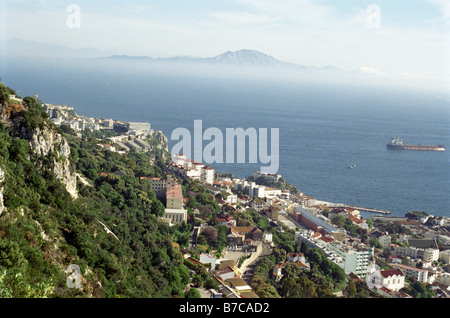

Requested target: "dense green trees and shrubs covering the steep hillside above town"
[{"left": 0, "top": 86, "right": 197, "bottom": 297}]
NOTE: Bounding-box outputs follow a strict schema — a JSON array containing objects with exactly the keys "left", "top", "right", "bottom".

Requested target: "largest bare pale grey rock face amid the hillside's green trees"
[{"left": 21, "top": 125, "right": 78, "bottom": 199}]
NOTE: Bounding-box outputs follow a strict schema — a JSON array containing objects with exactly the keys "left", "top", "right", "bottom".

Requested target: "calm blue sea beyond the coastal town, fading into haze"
[{"left": 0, "top": 61, "right": 450, "bottom": 217}]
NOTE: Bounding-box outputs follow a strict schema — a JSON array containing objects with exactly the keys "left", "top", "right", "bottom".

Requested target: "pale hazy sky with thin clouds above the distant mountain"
[{"left": 0, "top": 0, "right": 450, "bottom": 78}]
